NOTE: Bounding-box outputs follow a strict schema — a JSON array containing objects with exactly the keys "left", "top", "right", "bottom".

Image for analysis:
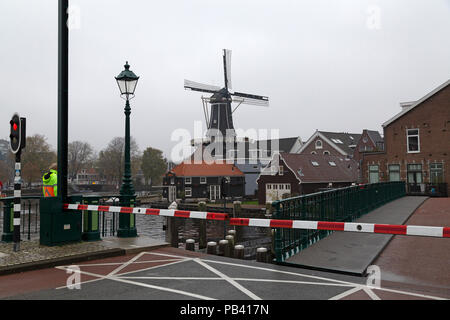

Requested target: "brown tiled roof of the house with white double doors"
[{"left": 260, "top": 152, "right": 358, "bottom": 183}]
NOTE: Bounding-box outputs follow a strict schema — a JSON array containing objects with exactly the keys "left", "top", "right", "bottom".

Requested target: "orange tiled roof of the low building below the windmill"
[{"left": 170, "top": 162, "right": 244, "bottom": 177}]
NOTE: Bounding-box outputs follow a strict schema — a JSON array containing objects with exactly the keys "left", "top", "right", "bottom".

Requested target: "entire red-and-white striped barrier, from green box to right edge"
[{"left": 63, "top": 204, "right": 450, "bottom": 238}]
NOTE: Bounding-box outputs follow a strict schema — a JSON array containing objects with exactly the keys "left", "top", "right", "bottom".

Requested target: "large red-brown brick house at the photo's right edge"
[{"left": 362, "top": 80, "right": 450, "bottom": 195}]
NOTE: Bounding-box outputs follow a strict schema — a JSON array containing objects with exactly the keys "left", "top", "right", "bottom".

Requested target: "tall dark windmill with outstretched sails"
[{"left": 184, "top": 49, "right": 269, "bottom": 143}]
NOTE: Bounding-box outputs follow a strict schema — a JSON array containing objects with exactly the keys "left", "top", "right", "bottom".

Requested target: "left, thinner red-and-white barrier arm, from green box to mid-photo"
[{"left": 63, "top": 203, "right": 228, "bottom": 221}]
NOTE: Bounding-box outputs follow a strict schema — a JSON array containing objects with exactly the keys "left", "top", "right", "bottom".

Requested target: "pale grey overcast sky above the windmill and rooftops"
[{"left": 0, "top": 0, "right": 450, "bottom": 160}]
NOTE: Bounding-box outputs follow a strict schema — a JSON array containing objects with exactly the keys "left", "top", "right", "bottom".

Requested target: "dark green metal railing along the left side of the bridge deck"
[{"left": 272, "top": 181, "right": 406, "bottom": 262}]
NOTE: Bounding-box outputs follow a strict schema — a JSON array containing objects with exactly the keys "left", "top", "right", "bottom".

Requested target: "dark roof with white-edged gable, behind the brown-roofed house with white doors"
[{"left": 299, "top": 130, "right": 361, "bottom": 155}]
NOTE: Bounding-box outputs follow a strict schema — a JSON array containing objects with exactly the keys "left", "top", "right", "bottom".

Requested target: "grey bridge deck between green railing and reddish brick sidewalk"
[{"left": 285, "top": 196, "right": 427, "bottom": 275}]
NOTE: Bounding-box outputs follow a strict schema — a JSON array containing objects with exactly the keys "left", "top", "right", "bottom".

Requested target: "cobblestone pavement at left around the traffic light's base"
[{"left": 0, "top": 240, "right": 114, "bottom": 268}]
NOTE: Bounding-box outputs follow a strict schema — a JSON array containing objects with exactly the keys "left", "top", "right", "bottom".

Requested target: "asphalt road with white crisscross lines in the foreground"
[{"left": 0, "top": 248, "right": 450, "bottom": 300}]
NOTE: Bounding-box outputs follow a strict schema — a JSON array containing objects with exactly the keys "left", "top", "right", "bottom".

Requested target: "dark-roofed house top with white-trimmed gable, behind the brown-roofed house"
[{"left": 298, "top": 130, "right": 361, "bottom": 158}]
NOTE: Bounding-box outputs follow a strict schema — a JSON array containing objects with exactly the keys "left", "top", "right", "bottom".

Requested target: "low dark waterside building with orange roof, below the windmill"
[{"left": 163, "top": 162, "right": 245, "bottom": 202}]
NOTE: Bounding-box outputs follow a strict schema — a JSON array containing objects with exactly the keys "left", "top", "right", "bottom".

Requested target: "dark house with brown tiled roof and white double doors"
[{"left": 257, "top": 152, "right": 358, "bottom": 204}]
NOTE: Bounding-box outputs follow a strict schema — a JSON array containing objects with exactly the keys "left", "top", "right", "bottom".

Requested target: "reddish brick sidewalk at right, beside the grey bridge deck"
[{"left": 374, "top": 198, "right": 450, "bottom": 295}]
